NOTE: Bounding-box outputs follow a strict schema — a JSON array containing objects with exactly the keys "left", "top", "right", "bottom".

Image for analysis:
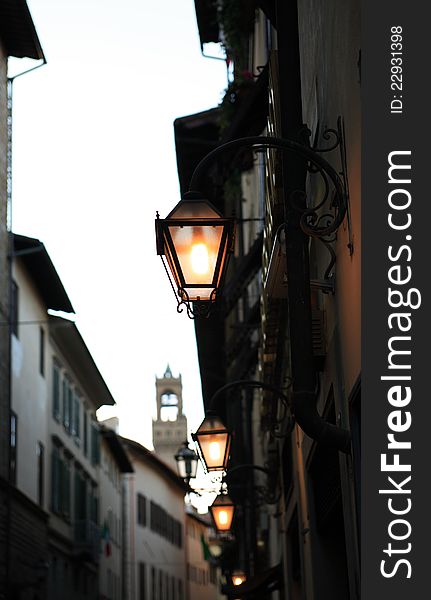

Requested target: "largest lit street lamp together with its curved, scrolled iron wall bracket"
[{"left": 156, "top": 124, "right": 348, "bottom": 318}]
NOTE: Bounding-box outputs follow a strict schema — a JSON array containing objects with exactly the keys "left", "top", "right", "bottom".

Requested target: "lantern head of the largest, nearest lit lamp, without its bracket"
[{"left": 156, "top": 192, "right": 235, "bottom": 318}]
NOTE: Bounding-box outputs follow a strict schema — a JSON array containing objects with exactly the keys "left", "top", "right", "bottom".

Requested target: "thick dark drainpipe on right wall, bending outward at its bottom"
[{"left": 275, "top": 0, "right": 351, "bottom": 453}]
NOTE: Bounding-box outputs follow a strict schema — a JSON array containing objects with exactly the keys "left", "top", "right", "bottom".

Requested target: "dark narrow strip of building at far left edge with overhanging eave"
[{"left": 0, "top": 0, "right": 44, "bottom": 599}]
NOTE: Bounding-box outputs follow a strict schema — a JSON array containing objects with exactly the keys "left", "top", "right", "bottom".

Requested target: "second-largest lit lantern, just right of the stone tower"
[{"left": 192, "top": 415, "right": 232, "bottom": 471}]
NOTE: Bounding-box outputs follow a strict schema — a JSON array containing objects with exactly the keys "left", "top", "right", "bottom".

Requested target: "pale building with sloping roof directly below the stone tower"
[{"left": 122, "top": 438, "right": 187, "bottom": 600}]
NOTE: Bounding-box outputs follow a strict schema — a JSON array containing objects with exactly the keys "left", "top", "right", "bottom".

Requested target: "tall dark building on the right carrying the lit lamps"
[{"left": 174, "top": 0, "right": 361, "bottom": 600}]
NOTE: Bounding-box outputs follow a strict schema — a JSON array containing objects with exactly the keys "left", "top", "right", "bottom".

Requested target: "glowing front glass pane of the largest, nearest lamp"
[{"left": 169, "top": 225, "right": 224, "bottom": 290}]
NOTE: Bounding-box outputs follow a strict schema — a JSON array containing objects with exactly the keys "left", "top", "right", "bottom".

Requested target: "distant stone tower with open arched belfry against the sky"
[{"left": 153, "top": 365, "right": 187, "bottom": 472}]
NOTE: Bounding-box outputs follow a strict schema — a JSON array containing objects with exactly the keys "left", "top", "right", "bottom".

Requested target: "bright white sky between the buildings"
[{"left": 13, "top": 0, "right": 226, "bottom": 447}]
